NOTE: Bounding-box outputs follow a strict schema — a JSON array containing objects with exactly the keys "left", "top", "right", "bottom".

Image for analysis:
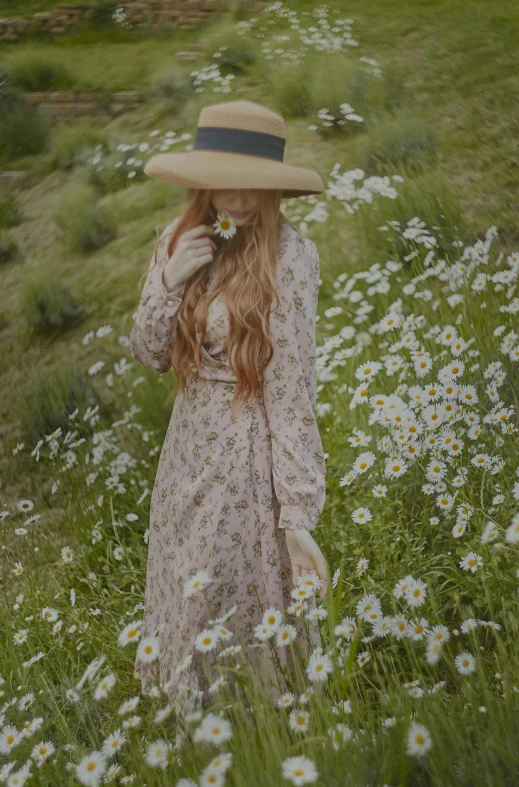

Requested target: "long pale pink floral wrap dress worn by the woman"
[{"left": 130, "top": 214, "right": 325, "bottom": 713}]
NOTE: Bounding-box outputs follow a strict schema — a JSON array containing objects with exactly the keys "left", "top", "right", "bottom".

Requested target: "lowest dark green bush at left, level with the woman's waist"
[{"left": 18, "top": 365, "right": 101, "bottom": 443}]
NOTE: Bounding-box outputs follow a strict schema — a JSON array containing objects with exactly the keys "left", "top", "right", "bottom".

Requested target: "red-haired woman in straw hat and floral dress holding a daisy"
[{"left": 130, "top": 101, "right": 328, "bottom": 713}]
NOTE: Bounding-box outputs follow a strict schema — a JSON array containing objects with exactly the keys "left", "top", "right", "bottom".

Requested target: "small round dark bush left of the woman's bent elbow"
[{"left": 20, "top": 268, "right": 85, "bottom": 334}]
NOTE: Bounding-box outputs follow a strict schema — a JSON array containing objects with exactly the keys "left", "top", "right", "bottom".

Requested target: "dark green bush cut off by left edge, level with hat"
[{"left": 0, "top": 69, "right": 49, "bottom": 163}]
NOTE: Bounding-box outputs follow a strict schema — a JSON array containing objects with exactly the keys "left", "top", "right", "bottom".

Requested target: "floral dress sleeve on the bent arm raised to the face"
[{"left": 130, "top": 220, "right": 186, "bottom": 374}]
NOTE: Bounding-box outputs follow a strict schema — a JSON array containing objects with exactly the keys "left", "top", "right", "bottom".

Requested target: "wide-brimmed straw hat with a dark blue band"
[{"left": 144, "top": 101, "right": 324, "bottom": 198}]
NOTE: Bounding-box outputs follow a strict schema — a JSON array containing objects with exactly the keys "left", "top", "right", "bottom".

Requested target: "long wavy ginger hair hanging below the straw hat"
[{"left": 142, "top": 188, "right": 296, "bottom": 418}]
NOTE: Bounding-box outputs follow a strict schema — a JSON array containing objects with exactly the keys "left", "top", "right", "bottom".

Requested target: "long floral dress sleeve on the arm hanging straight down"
[{"left": 263, "top": 230, "right": 326, "bottom": 530}]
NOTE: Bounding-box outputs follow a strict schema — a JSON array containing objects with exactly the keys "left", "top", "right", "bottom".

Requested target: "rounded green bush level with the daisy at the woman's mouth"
[{"left": 54, "top": 183, "right": 116, "bottom": 252}]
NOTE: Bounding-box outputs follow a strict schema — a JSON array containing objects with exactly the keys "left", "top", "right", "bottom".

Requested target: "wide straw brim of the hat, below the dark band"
[{"left": 144, "top": 150, "right": 324, "bottom": 198}]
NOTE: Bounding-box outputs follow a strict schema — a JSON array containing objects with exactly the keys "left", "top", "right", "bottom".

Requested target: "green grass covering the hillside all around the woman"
[{"left": 0, "top": 0, "right": 519, "bottom": 787}]
